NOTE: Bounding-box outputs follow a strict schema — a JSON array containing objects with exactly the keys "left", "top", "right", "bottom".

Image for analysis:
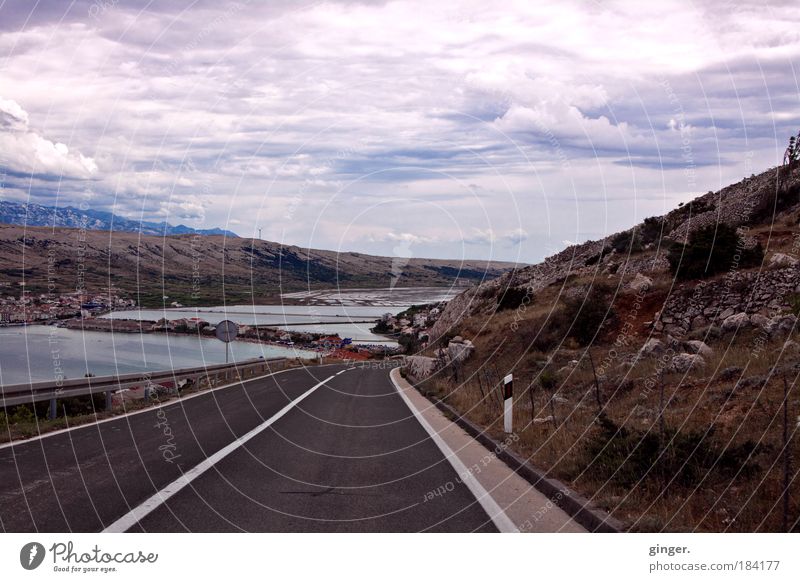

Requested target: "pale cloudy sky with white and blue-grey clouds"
[{"left": 0, "top": 0, "right": 800, "bottom": 262}]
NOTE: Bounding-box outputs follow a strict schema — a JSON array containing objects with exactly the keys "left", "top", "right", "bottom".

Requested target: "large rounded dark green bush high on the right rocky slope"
[{"left": 667, "top": 224, "right": 764, "bottom": 281}]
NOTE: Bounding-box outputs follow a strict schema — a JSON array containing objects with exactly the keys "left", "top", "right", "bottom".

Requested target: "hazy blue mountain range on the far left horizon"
[{"left": 0, "top": 200, "right": 238, "bottom": 238}]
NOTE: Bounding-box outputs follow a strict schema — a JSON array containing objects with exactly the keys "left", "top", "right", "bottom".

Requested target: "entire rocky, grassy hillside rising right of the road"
[{"left": 406, "top": 167, "right": 800, "bottom": 532}]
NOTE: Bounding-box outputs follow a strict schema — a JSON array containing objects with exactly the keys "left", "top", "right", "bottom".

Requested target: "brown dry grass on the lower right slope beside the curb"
[{"left": 422, "top": 306, "right": 800, "bottom": 532}]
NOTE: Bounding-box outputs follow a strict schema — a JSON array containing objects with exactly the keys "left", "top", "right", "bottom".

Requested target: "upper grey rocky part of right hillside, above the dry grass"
[{"left": 430, "top": 167, "right": 800, "bottom": 340}]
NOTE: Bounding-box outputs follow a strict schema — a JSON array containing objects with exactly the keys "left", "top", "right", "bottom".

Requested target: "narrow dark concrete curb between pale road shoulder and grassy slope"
[{"left": 412, "top": 383, "right": 625, "bottom": 533}]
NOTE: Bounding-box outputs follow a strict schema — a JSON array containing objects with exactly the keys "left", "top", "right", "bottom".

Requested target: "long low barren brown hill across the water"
[{"left": 0, "top": 225, "right": 513, "bottom": 306}]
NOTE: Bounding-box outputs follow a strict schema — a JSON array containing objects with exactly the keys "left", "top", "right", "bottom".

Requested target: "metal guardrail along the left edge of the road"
[{"left": 0, "top": 358, "right": 290, "bottom": 419}]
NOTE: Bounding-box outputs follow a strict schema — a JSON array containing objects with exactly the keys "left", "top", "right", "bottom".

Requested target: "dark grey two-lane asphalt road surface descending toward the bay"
[{"left": 0, "top": 366, "right": 495, "bottom": 532}]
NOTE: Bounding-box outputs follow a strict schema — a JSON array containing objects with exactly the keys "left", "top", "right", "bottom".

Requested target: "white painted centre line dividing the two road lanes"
[{"left": 103, "top": 374, "right": 336, "bottom": 533}]
